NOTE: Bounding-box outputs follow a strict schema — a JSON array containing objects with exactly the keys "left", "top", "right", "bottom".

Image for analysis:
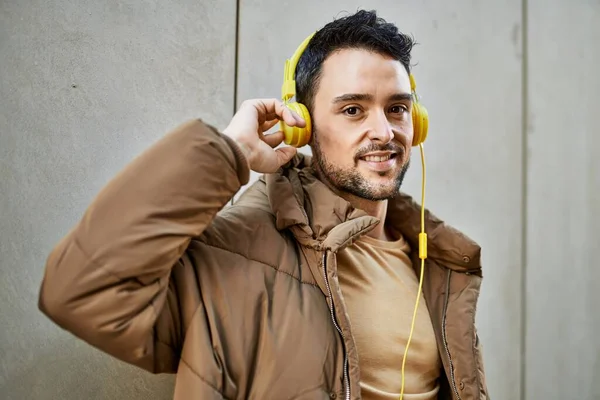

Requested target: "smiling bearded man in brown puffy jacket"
[{"left": 40, "top": 11, "right": 487, "bottom": 400}]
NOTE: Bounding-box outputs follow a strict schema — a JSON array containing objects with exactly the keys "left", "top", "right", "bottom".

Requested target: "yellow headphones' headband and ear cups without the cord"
[{"left": 279, "top": 32, "right": 429, "bottom": 147}]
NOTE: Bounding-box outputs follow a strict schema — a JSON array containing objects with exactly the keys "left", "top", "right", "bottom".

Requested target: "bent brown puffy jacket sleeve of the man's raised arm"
[{"left": 38, "top": 121, "right": 249, "bottom": 373}]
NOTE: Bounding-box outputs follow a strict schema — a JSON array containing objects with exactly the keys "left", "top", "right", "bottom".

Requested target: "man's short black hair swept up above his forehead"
[{"left": 296, "top": 10, "right": 415, "bottom": 112}]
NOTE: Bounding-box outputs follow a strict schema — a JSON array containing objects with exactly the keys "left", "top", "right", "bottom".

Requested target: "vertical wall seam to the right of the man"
[{"left": 520, "top": 0, "right": 529, "bottom": 400}]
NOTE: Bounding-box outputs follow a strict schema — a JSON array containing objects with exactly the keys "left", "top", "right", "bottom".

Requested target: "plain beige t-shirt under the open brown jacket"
[{"left": 338, "top": 236, "right": 441, "bottom": 400}]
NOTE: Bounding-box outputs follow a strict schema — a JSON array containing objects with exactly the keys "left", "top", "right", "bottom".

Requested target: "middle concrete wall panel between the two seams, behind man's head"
[{"left": 238, "top": 0, "right": 522, "bottom": 399}]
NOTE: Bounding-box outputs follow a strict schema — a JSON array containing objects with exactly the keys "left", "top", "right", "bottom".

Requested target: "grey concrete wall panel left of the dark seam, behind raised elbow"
[{"left": 0, "top": 0, "right": 236, "bottom": 400}]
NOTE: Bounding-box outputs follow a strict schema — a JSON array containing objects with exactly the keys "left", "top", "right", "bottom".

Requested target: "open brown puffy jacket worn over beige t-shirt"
[{"left": 39, "top": 117, "right": 488, "bottom": 400}]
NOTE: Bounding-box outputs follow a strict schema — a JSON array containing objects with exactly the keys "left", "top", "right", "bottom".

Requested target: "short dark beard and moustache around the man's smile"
[{"left": 312, "top": 131, "right": 410, "bottom": 201}]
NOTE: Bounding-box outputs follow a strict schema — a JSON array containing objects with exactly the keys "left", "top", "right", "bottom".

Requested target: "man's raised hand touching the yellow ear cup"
[{"left": 223, "top": 99, "right": 306, "bottom": 173}]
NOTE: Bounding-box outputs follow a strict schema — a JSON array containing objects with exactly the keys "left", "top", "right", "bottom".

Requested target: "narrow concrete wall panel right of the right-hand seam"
[{"left": 525, "top": 0, "right": 600, "bottom": 400}]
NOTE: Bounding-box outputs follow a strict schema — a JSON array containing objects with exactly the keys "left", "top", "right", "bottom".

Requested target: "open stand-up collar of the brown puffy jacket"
[{"left": 265, "top": 153, "right": 481, "bottom": 272}]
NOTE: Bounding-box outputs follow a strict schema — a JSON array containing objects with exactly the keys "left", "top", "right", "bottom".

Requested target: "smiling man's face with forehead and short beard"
[{"left": 311, "top": 49, "right": 413, "bottom": 200}]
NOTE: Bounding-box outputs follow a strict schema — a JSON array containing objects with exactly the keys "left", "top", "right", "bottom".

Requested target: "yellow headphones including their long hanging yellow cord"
[{"left": 280, "top": 33, "right": 429, "bottom": 400}]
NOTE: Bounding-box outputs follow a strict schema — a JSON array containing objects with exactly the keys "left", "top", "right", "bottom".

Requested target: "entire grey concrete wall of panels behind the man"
[{"left": 0, "top": 0, "right": 600, "bottom": 400}]
